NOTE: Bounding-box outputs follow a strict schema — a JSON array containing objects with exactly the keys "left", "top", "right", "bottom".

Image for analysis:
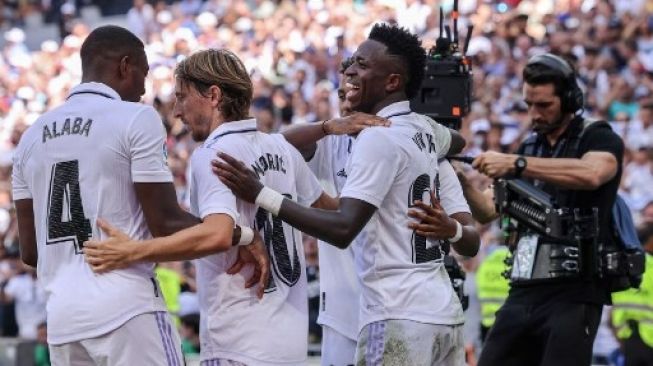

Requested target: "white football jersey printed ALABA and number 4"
[{"left": 13, "top": 83, "right": 172, "bottom": 345}]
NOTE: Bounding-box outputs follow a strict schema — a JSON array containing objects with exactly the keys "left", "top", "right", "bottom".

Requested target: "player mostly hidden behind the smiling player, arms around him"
[{"left": 284, "top": 59, "right": 479, "bottom": 366}]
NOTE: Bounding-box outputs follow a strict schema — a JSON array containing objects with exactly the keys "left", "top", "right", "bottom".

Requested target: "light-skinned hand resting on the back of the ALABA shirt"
[{"left": 84, "top": 219, "right": 139, "bottom": 273}]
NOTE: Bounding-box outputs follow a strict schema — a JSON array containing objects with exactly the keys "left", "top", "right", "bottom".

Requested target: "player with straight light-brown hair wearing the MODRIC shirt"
[{"left": 85, "top": 50, "right": 330, "bottom": 366}]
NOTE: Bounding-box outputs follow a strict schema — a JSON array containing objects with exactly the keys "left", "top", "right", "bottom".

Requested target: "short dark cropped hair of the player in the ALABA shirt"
[{"left": 80, "top": 25, "right": 145, "bottom": 73}]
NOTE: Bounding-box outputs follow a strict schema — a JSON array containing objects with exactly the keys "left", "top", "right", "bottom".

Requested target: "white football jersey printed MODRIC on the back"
[{"left": 190, "top": 119, "right": 322, "bottom": 365}]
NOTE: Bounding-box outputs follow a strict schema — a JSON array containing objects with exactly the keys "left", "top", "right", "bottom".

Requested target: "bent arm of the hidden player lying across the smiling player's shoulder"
[{"left": 282, "top": 113, "right": 390, "bottom": 160}]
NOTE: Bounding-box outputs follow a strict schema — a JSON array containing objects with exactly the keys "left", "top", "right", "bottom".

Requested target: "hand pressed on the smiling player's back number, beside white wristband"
[{"left": 408, "top": 191, "right": 457, "bottom": 240}]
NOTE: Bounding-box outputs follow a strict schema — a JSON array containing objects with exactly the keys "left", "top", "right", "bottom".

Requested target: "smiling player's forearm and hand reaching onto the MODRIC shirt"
[{"left": 212, "top": 153, "right": 376, "bottom": 249}]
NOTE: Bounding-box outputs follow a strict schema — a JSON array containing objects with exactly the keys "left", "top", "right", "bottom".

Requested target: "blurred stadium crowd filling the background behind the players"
[{"left": 0, "top": 0, "right": 653, "bottom": 364}]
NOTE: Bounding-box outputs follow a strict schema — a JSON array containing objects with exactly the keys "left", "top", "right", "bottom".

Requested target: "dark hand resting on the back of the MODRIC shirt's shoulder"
[{"left": 211, "top": 152, "right": 263, "bottom": 203}]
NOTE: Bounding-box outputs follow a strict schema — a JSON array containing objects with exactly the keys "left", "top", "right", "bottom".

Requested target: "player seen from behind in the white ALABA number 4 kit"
[{"left": 12, "top": 26, "right": 260, "bottom": 366}]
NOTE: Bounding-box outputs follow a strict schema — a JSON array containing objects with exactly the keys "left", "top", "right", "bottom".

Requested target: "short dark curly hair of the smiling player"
[{"left": 368, "top": 23, "right": 426, "bottom": 98}]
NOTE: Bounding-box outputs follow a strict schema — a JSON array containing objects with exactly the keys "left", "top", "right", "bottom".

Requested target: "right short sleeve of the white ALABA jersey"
[{"left": 127, "top": 107, "right": 172, "bottom": 183}]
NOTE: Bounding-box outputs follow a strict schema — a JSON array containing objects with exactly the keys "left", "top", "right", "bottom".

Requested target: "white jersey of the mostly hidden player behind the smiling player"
[{"left": 308, "top": 135, "right": 360, "bottom": 340}]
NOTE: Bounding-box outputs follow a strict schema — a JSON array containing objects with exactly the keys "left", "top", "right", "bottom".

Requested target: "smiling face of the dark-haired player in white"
[{"left": 345, "top": 39, "right": 399, "bottom": 114}]
